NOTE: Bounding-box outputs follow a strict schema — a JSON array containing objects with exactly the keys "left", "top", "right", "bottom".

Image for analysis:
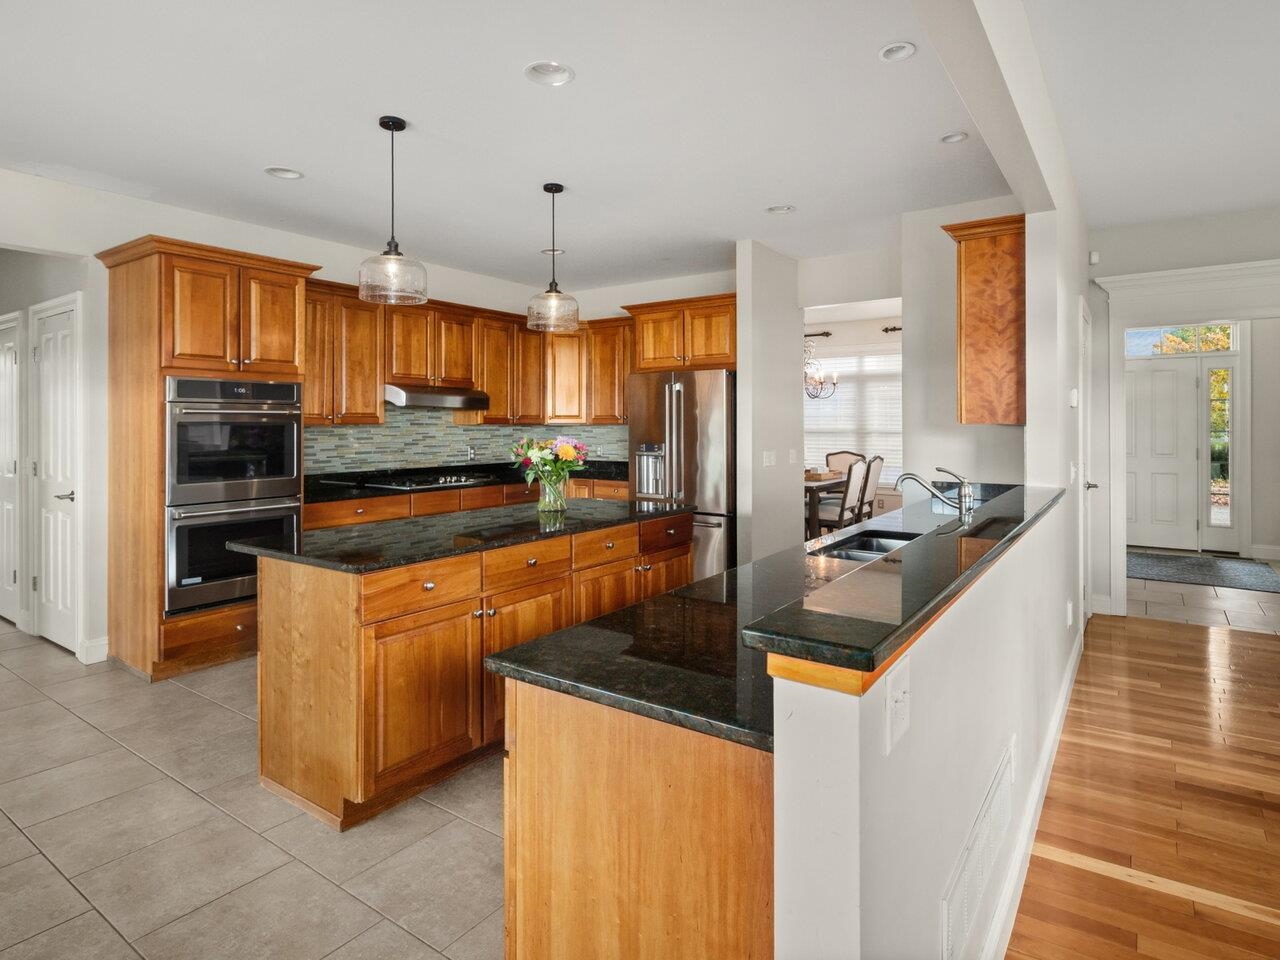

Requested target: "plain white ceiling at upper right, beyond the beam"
[{"left": 1024, "top": 0, "right": 1280, "bottom": 227}]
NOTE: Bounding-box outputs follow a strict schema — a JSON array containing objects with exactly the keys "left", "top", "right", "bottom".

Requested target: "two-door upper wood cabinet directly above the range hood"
[{"left": 387, "top": 306, "right": 476, "bottom": 389}]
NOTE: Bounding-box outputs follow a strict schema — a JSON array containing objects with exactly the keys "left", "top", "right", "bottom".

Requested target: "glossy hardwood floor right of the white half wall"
[{"left": 1006, "top": 617, "right": 1280, "bottom": 960}]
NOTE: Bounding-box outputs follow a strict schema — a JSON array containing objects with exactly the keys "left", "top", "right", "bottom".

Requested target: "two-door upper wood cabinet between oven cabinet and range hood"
[{"left": 302, "top": 280, "right": 387, "bottom": 426}]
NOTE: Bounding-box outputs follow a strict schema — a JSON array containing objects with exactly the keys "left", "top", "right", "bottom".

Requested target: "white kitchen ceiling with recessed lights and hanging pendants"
[{"left": 0, "top": 0, "right": 1007, "bottom": 289}]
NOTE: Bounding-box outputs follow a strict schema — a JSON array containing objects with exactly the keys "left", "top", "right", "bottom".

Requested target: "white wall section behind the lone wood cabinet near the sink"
[{"left": 902, "top": 197, "right": 1030, "bottom": 483}]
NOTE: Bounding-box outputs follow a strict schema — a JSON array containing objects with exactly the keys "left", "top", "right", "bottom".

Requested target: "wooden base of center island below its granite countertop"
[{"left": 257, "top": 521, "right": 691, "bottom": 829}]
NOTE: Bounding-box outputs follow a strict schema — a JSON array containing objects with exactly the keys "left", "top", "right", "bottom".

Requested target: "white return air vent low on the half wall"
[{"left": 942, "top": 744, "right": 1014, "bottom": 960}]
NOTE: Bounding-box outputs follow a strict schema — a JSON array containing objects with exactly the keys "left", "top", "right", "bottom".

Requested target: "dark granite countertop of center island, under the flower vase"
[{"left": 227, "top": 500, "right": 694, "bottom": 573}]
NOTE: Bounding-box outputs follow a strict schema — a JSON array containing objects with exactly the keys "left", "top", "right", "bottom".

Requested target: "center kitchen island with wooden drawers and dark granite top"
[{"left": 228, "top": 500, "right": 692, "bottom": 829}]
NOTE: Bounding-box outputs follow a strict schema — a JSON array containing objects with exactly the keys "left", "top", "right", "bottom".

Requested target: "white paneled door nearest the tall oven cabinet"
[{"left": 31, "top": 307, "right": 79, "bottom": 650}]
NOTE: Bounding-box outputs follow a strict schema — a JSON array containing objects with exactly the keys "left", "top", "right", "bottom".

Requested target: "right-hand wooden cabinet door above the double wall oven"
[{"left": 239, "top": 268, "right": 306, "bottom": 376}]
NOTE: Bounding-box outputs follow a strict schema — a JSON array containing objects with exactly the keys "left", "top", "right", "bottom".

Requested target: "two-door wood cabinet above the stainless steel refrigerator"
[{"left": 623, "top": 293, "right": 737, "bottom": 370}]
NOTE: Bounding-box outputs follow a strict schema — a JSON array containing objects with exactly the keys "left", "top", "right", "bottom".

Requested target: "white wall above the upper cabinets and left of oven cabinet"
[{"left": 0, "top": 170, "right": 534, "bottom": 660}]
